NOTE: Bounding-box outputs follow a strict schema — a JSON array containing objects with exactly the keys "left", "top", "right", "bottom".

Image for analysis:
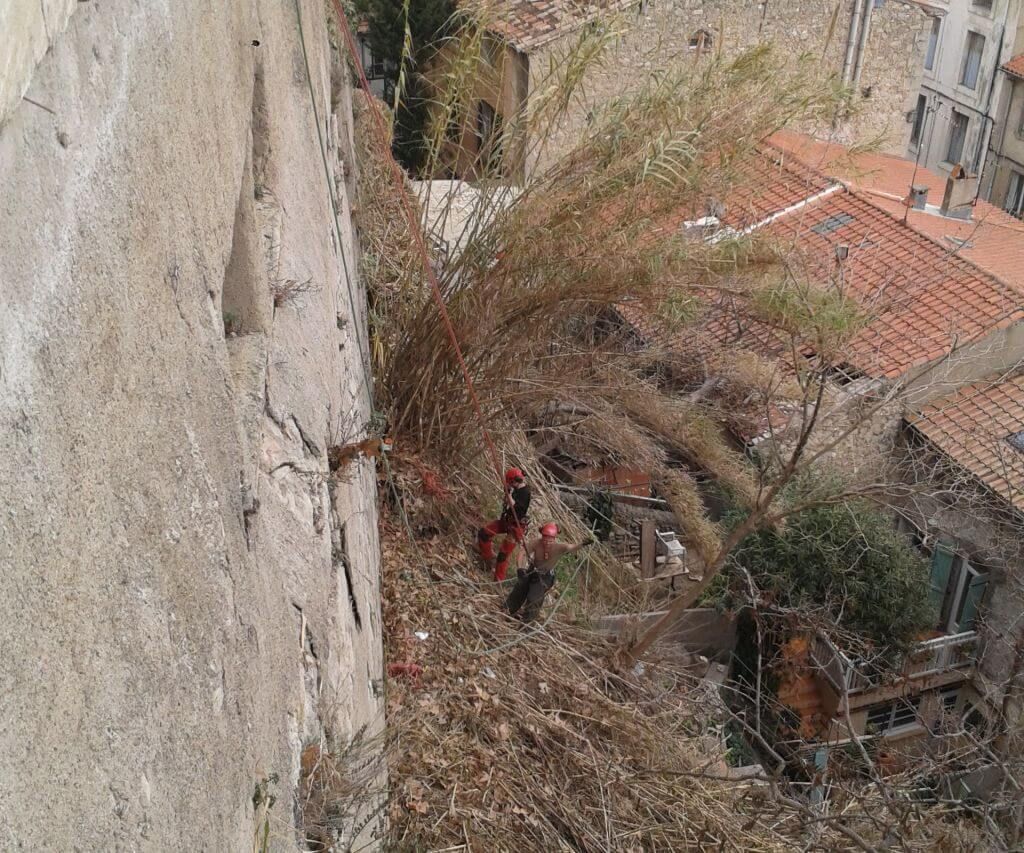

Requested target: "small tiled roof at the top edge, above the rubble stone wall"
[{"left": 477, "top": 0, "right": 638, "bottom": 53}]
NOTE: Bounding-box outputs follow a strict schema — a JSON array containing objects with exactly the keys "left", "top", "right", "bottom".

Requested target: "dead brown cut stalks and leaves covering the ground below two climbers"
[{"left": 374, "top": 460, "right": 977, "bottom": 853}]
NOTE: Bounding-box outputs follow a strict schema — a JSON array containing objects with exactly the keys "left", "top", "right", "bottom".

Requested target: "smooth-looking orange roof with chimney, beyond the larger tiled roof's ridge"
[{"left": 771, "top": 128, "right": 1024, "bottom": 293}]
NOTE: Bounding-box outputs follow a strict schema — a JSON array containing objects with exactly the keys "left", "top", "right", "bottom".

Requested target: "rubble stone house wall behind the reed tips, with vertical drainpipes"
[{"left": 529, "top": 0, "right": 930, "bottom": 173}]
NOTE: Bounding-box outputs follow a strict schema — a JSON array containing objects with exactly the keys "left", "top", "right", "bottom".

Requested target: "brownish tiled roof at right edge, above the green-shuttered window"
[{"left": 907, "top": 375, "right": 1024, "bottom": 509}]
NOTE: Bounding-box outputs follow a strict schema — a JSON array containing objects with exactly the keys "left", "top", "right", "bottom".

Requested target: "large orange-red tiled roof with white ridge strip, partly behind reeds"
[{"left": 627, "top": 146, "right": 1024, "bottom": 378}]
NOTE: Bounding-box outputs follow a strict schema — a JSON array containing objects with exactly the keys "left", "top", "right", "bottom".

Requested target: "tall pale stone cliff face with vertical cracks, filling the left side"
[{"left": 0, "top": 0, "right": 383, "bottom": 850}]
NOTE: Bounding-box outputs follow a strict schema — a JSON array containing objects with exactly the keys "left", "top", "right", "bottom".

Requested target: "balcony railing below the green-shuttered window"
[{"left": 811, "top": 631, "right": 978, "bottom": 696}]
